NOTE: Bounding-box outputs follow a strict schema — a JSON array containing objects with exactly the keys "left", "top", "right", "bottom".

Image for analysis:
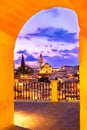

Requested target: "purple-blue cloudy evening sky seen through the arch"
[{"left": 14, "top": 8, "right": 80, "bottom": 68}]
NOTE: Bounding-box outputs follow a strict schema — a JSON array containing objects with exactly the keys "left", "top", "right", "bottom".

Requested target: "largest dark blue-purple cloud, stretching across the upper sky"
[{"left": 19, "top": 27, "right": 78, "bottom": 43}]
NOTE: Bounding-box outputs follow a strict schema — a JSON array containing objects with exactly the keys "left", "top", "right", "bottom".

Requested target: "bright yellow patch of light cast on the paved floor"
[{"left": 14, "top": 111, "right": 45, "bottom": 129}]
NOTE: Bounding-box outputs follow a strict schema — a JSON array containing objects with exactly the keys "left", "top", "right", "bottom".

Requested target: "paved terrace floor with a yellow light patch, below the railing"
[{"left": 3, "top": 101, "right": 80, "bottom": 130}]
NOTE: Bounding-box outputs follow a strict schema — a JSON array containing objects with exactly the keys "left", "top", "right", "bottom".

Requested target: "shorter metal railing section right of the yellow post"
[{"left": 58, "top": 81, "right": 80, "bottom": 100}]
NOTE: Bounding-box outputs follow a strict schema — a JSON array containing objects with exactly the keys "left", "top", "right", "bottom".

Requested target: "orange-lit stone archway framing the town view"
[{"left": 0, "top": 0, "right": 87, "bottom": 130}]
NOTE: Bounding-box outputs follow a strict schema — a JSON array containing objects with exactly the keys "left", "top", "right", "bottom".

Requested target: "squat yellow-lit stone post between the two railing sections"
[{"left": 51, "top": 80, "right": 58, "bottom": 102}]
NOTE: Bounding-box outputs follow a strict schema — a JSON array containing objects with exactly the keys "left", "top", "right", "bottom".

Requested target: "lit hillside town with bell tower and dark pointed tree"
[{"left": 14, "top": 54, "right": 79, "bottom": 82}]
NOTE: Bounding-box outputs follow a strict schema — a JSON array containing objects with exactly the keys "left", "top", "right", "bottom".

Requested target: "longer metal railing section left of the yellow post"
[{"left": 14, "top": 82, "right": 51, "bottom": 100}]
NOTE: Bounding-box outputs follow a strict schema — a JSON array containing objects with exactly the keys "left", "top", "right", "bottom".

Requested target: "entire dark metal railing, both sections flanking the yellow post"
[{"left": 14, "top": 81, "right": 80, "bottom": 101}]
